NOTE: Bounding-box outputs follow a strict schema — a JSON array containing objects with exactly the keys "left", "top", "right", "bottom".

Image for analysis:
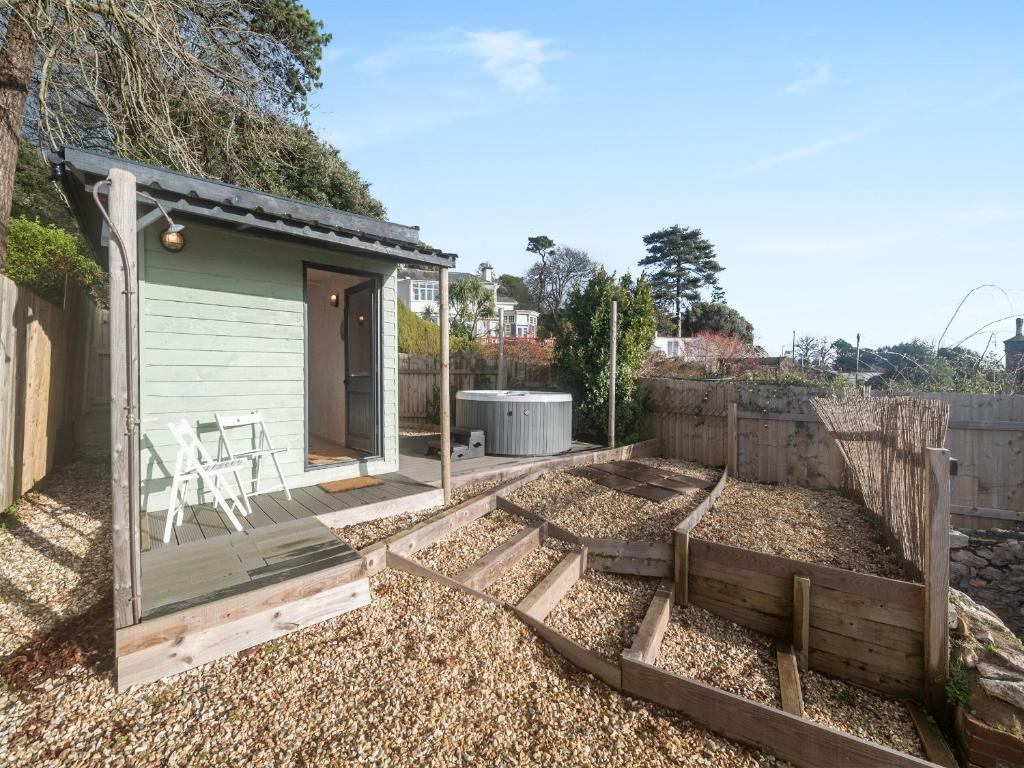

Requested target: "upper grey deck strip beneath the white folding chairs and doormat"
[{"left": 142, "top": 472, "right": 440, "bottom": 555}]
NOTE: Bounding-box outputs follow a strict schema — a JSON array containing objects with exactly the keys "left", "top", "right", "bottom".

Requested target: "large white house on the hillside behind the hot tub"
[{"left": 398, "top": 262, "right": 541, "bottom": 338}]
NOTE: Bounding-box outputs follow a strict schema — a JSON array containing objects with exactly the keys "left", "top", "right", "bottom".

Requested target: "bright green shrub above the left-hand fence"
[{"left": 4, "top": 216, "right": 108, "bottom": 306}]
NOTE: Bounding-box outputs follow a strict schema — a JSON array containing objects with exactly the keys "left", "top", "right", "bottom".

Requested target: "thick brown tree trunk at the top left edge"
[{"left": 0, "top": 11, "right": 36, "bottom": 269}]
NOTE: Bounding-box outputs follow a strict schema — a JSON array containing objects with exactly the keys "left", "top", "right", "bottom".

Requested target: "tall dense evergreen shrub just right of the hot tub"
[{"left": 554, "top": 268, "right": 655, "bottom": 442}]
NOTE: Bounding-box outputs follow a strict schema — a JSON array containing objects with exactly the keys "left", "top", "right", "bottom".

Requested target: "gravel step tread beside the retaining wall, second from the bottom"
[{"left": 657, "top": 605, "right": 781, "bottom": 708}]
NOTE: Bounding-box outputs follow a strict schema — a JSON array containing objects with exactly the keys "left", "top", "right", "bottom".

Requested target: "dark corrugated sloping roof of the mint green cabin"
[{"left": 50, "top": 147, "right": 457, "bottom": 268}]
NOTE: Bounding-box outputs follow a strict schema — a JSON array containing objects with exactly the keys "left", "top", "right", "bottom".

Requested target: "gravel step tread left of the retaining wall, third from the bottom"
[{"left": 545, "top": 570, "right": 658, "bottom": 660}]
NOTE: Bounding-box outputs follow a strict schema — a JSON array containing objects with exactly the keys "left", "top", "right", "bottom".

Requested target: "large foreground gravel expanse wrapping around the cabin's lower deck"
[{"left": 0, "top": 468, "right": 790, "bottom": 767}]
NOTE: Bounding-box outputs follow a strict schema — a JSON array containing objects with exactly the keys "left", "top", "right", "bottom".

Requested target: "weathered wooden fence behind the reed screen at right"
[{"left": 642, "top": 378, "right": 1024, "bottom": 518}]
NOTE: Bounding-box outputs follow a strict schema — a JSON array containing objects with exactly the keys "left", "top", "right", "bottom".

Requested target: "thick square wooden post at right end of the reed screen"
[{"left": 925, "top": 449, "right": 949, "bottom": 719}]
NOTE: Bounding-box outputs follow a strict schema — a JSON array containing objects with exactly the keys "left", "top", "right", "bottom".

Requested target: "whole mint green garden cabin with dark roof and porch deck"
[{"left": 53, "top": 148, "right": 456, "bottom": 688}]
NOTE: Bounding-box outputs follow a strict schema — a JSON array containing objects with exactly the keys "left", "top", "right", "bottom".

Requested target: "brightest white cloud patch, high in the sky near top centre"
[{"left": 450, "top": 30, "right": 565, "bottom": 93}]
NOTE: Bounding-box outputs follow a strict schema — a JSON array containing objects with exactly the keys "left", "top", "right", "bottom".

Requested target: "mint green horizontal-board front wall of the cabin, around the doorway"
[{"left": 139, "top": 223, "right": 398, "bottom": 510}]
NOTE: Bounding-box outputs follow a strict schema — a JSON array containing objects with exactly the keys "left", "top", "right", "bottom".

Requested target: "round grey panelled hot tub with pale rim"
[{"left": 455, "top": 389, "right": 572, "bottom": 456}]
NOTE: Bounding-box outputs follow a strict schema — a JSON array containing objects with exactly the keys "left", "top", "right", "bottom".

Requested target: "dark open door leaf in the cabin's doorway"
[{"left": 345, "top": 280, "right": 377, "bottom": 454}]
